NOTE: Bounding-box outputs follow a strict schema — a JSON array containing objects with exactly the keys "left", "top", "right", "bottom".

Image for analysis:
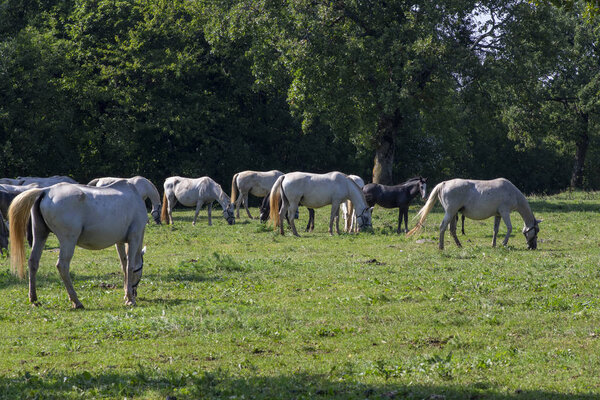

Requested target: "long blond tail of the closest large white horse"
[{"left": 8, "top": 189, "right": 44, "bottom": 279}]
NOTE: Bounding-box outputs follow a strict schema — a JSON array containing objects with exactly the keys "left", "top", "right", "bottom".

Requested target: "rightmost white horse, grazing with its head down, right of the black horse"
[{"left": 407, "top": 178, "right": 541, "bottom": 250}]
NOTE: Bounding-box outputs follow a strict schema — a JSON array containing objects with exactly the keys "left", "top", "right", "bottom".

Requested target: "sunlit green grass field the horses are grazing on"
[{"left": 0, "top": 193, "right": 600, "bottom": 400}]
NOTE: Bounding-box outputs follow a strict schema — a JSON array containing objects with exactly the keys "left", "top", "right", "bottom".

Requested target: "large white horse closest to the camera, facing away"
[{"left": 8, "top": 182, "right": 148, "bottom": 308}]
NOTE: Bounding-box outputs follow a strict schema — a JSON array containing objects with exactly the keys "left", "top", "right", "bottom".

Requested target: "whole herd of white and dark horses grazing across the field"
[{"left": 0, "top": 170, "right": 540, "bottom": 308}]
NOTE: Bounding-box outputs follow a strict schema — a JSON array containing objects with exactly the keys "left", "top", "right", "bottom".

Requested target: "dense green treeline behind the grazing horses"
[{"left": 0, "top": 0, "right": 600, "bottom": 193}]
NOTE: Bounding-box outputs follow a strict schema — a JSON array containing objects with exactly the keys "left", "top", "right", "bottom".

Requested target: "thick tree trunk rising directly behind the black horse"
[{"left": 373, "top": 111, "right": 402, "bottom": 185}]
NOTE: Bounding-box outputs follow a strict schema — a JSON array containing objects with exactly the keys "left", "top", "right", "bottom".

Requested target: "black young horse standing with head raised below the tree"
[{"left": 363, "top": 176, "right": 427, "bottom": 233}]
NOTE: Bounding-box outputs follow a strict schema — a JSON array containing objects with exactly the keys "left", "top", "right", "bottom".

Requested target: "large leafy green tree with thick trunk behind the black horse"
[{"left": 207, "top": 0, "right": 480, "bottom": 184}]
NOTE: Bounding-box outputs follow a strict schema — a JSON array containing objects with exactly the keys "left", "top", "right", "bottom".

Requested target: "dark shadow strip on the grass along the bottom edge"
[{"left": 0, "top": 366, "right": 598, "bottom": 400}]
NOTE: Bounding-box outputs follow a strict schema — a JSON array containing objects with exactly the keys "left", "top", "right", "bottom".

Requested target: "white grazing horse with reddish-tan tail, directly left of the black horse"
[{"left": 270, "top": 172, "right": 373, "bottom": 236}]
